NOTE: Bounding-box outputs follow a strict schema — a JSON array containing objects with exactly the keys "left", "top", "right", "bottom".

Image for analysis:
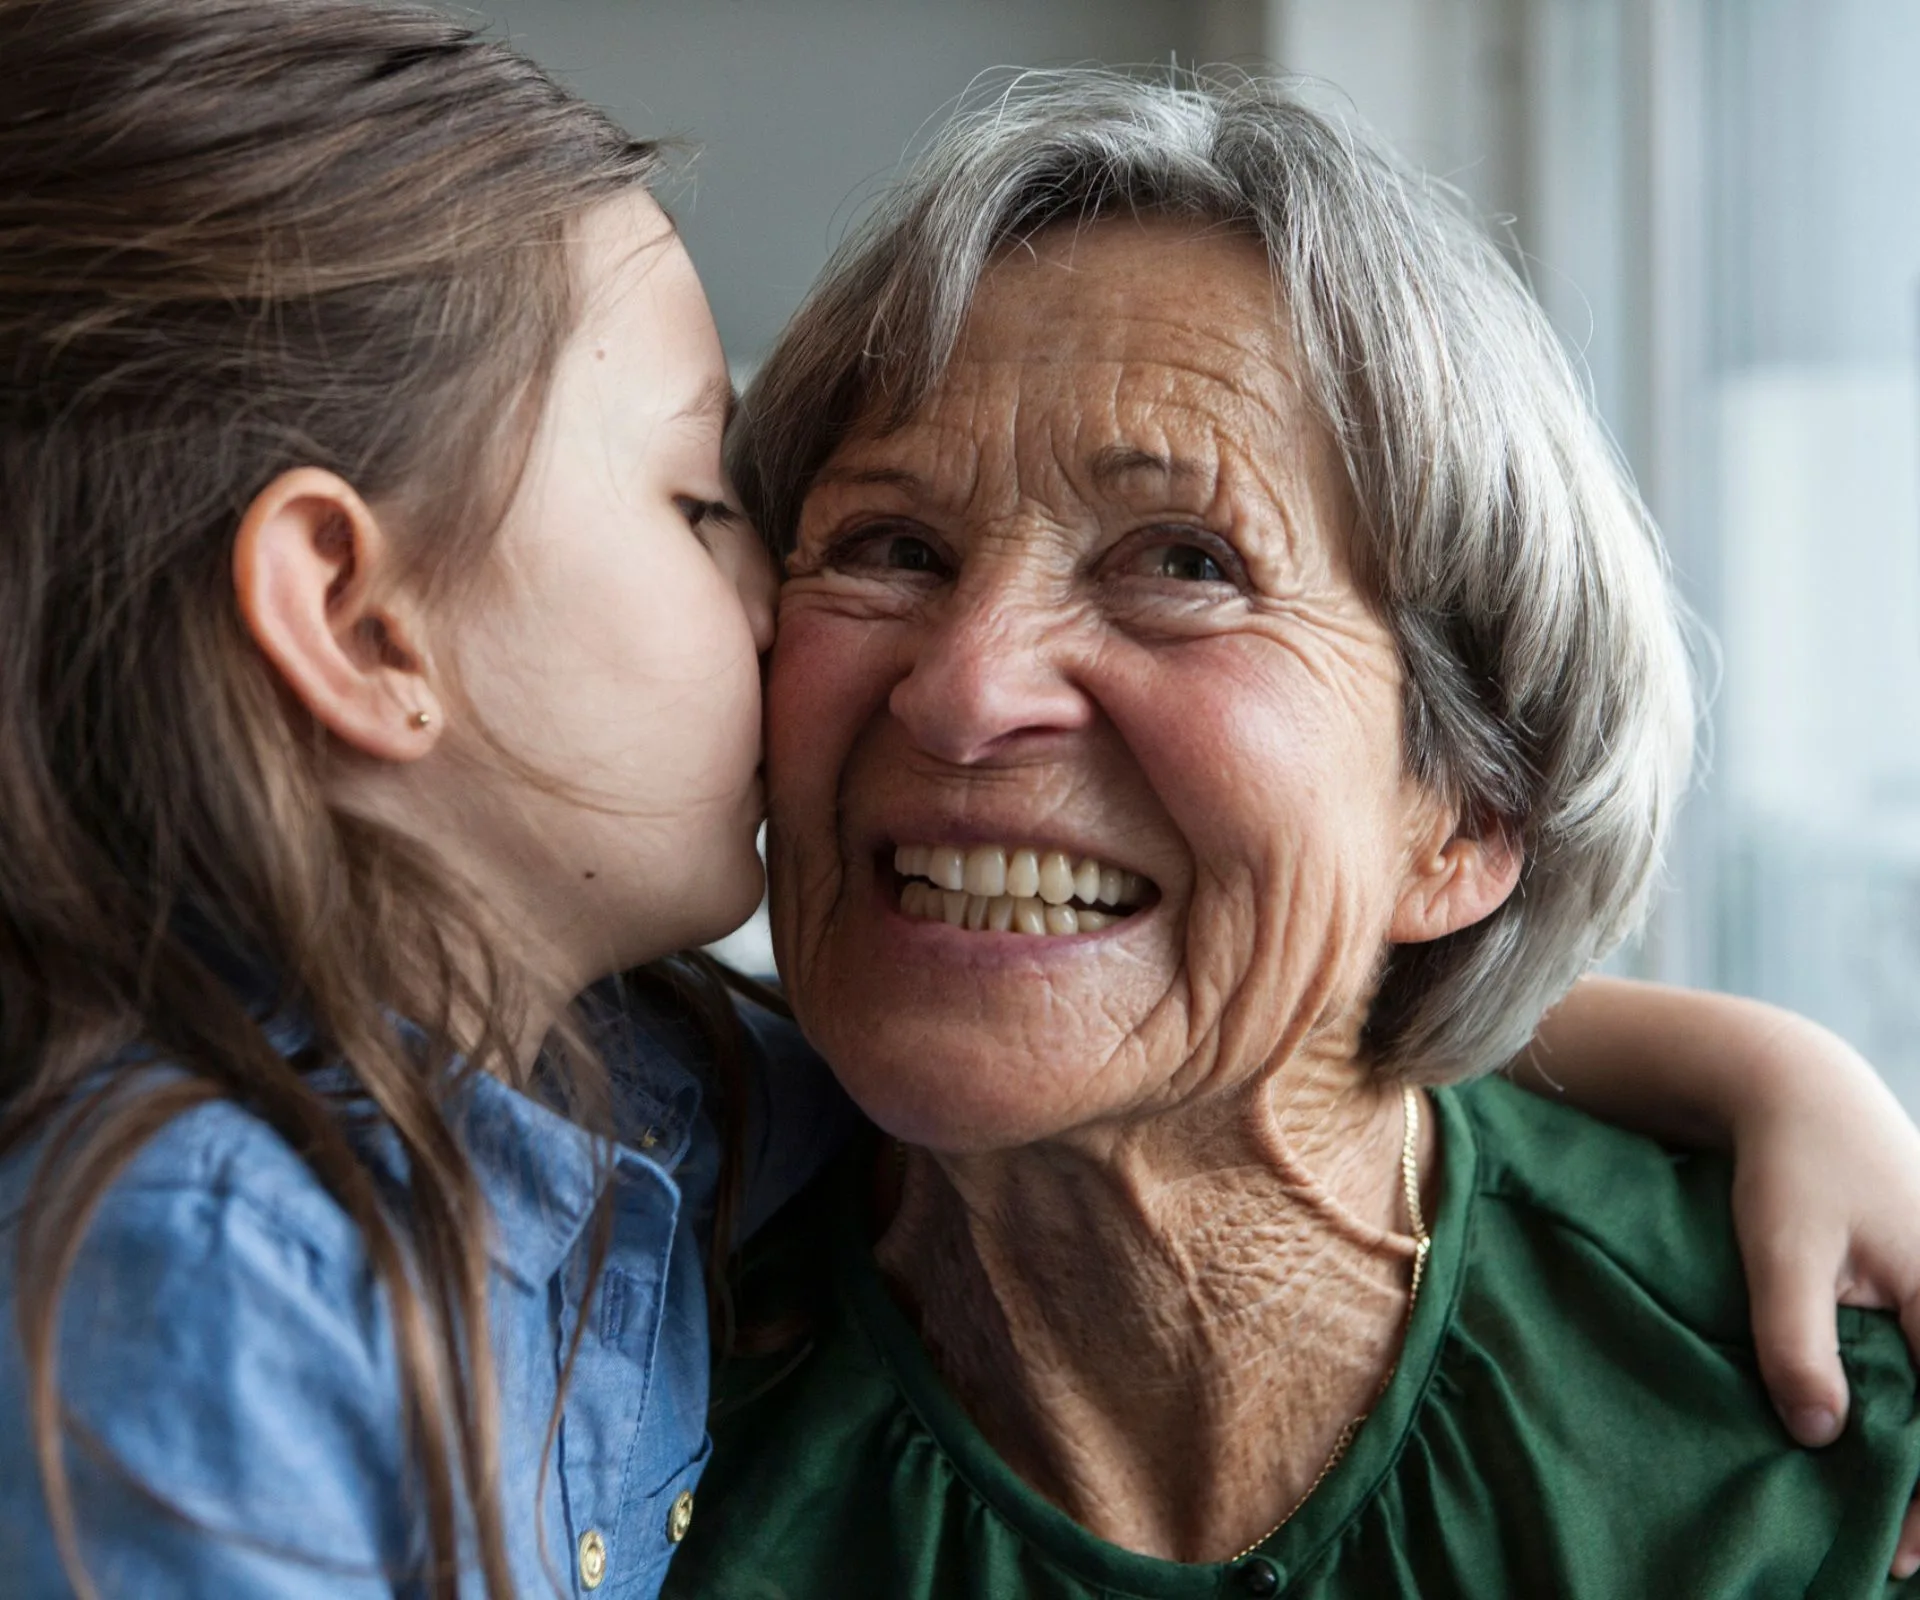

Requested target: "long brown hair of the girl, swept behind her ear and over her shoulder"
[{"left": 0, "top": 0, "right": 756, "bottom": 1596}]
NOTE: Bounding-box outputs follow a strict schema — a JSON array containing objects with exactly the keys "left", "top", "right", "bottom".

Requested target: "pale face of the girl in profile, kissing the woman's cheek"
[{"left": 459, "top": 196, "right": 774, "bottom": 978}]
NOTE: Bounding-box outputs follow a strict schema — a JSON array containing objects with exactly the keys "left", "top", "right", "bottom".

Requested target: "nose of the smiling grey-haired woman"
[{"left": 887, "top": 592, "right": 1092, "bottom": 766}]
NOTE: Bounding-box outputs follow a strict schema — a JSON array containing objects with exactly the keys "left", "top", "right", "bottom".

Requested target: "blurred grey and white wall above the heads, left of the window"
[{"left": 467, "top": 0, "right": 1543, "bottom": 378}]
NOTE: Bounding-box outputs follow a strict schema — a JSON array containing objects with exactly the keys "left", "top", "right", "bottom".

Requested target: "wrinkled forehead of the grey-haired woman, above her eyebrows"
[{"left": 858, "top": 255, "right": 1344, "bottom": 595}]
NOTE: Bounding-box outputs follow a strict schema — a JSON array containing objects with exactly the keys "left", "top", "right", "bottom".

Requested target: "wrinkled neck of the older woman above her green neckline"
[{"left": 876, "top": 1062, "right": 1430, "bottom": 1562}]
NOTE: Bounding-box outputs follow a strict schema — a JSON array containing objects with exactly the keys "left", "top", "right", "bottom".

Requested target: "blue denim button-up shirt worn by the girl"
[{"left": 0, "top": 1006, "right": 851, "bottom": 1600}]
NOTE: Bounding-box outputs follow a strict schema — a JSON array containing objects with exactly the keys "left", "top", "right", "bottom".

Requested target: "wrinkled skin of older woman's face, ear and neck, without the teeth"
[{"left": 768, "top": 221, "right": 1517, "bottom": 1560}]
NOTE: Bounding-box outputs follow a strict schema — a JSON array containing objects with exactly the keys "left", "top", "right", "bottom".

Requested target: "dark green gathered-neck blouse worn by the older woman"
[{"left": 666, "top": 1079, "right": 1920, "bottom": 1600}]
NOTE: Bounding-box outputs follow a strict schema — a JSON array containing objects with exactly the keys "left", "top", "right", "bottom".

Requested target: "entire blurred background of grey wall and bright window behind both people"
[{"left": 470, "top": 0, "right": 1920, "bottom": 1108}]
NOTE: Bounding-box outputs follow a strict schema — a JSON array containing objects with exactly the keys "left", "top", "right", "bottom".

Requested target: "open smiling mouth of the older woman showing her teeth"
[{"left": 893, "top": 845, "right": 1154, "bottom": 937}]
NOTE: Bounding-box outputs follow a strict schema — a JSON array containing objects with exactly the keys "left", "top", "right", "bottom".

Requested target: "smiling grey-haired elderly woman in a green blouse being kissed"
[{"left": 672, "top": 75, "right": 1920, "bottom": 1600}]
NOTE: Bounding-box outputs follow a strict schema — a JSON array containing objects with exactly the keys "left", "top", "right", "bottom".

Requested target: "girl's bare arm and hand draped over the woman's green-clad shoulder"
[{"left": 1513, "top": 978, "right": 1920, "bottom": 1577}]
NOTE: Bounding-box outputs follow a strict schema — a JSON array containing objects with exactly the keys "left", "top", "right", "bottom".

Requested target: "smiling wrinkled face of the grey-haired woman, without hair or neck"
[{"left": 768, "top": 219, "right": 1448, "bottom": 1151}]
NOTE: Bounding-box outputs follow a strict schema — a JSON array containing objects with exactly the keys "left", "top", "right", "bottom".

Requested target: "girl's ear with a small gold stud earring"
[{"left": 234, "top": 467, "right": 442, "bottom": 761}]
